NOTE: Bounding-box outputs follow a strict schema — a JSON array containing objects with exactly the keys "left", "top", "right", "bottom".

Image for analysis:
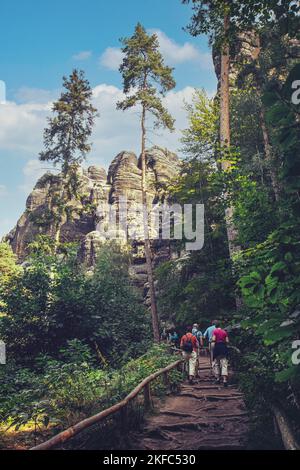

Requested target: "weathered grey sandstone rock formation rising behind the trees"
[{"left": 6, "top": 147, "right": 180, "bottom": 287}]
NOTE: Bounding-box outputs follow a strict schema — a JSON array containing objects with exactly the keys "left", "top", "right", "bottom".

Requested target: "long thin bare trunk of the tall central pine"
[{"left": 141, "top": 106, "right": 160, "bottom": 343}]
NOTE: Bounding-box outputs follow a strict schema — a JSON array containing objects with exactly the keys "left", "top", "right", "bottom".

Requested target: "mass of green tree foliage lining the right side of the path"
[{"left": 166, "top": 6, "right": 300, "bottom": 448}]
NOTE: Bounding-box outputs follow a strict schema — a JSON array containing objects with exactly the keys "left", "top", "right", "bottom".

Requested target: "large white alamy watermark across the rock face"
[{"left": 96, "top": 196, "right": 204, "bottom": 251}]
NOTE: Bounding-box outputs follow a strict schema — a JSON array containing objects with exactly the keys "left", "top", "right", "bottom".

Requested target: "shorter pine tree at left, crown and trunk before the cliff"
[{"left": 39, "top": 69, "right": 97, "bottom": 243}]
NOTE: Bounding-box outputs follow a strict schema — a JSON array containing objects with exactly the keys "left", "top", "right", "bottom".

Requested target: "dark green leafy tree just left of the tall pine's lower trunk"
[{"left": 84, "top": 243, "right": 150, "bottom": 364}]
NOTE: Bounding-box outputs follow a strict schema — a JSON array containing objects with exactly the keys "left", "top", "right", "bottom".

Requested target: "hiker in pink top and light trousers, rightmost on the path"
[{"left": 211, "top": 322, "right": 229, "bottom": 387}]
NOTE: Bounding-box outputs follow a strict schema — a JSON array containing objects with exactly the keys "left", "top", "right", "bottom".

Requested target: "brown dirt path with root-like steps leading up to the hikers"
[{"left": 131, "top": 357, "right": 248, "bottom": 450}]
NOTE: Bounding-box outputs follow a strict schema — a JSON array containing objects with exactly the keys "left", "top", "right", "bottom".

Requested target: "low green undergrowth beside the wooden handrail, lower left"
[{"left": 0, "top": 340, "right": 181, "bottom": 444}]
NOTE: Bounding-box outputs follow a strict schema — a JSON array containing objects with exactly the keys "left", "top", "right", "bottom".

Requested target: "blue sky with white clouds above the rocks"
[{"left": 0, "top": 0, "right": 216, "bottom": 238}]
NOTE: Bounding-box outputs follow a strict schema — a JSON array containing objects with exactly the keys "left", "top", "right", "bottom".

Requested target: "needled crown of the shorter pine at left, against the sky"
[{"left": 40, "top": 70, "right": 96, "bottom": 180}]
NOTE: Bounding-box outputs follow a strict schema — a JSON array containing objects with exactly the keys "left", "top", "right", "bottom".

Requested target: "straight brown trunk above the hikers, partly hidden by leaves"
[{"left": 220, "top": 16, "right": 239, "bottom": 258}]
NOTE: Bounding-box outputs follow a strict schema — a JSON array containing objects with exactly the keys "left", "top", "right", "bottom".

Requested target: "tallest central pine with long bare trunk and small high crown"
[{"left": 117, "top": 23, "right": 175, "bottom": 342}]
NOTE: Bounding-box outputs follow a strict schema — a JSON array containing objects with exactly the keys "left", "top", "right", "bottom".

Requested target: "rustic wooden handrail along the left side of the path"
[{"left": 30, "top": 359, "right": 184, "bottom": 450}]
